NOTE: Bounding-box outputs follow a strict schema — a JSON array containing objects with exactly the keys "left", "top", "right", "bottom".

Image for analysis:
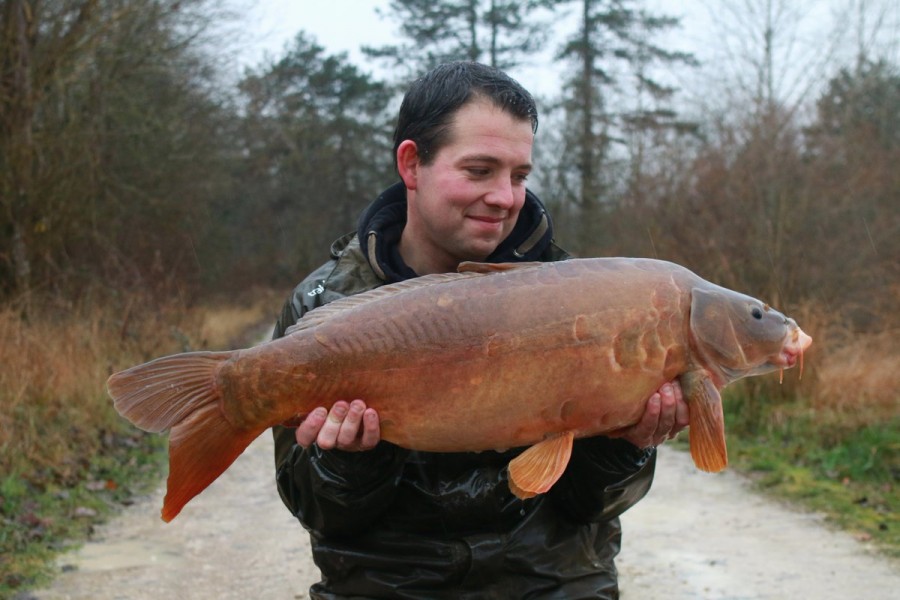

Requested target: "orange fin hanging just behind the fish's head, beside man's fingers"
[{"left": 681, "top": 371, "right": 728, "bottom": 473}]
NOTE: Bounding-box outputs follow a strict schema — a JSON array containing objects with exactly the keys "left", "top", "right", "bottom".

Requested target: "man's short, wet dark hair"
[{"left": 394, "top": 61, "right": 538, "bottom": 165}]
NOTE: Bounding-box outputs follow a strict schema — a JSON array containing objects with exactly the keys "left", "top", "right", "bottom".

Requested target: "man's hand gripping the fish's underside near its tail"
[{"left": 295, "top": 400, "right": 381, "bottom": 452}]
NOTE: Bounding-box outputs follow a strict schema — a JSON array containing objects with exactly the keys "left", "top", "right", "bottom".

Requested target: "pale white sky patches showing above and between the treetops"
[{"left": 228, "top": 0, "right": 900, "bottom": 106}]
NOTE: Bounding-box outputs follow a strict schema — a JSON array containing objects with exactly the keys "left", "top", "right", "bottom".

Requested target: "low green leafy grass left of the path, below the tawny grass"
[{"left": 0, "top": 424, "right": 165, "bottom": 598}]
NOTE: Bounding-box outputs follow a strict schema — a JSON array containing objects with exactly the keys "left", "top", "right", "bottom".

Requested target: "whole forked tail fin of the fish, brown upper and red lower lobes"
[{"left": 107, "top": 352, "right": 263, "bottom": 522}]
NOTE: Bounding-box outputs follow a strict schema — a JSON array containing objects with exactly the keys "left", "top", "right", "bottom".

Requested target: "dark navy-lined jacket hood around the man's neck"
[{"left": 357, "top": 181, "right": 553, "bottom": 283}]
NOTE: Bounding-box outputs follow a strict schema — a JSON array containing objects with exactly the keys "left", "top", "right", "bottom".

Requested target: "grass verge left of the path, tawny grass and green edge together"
[{"left": 0, "top": 291, "right": 281, "bottom": 598}]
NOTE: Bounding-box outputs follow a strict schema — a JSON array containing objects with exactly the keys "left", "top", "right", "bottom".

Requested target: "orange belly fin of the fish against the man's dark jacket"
[{"left": 508, "top": 431, "right": 575, "bottom": 500}]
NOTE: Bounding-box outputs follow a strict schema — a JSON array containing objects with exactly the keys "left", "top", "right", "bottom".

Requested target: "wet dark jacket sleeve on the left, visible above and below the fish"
[{"left": 272, "top": 271, "right": 408, "bottom": 536}]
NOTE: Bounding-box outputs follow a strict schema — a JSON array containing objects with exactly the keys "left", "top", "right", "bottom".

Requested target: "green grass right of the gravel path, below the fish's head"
[{"left": 712, "top": 394, "right": 900, "bottom": 557}]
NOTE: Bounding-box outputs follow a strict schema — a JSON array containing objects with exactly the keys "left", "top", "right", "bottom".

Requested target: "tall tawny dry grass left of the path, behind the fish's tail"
[{"left": 0, "top": 293, "right": 280, "bottom": 487}]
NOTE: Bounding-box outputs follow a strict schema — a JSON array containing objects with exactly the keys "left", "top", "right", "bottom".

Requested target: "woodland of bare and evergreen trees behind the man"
[{"left": 0, "top": 0, "right": 900, "bottom": 322}]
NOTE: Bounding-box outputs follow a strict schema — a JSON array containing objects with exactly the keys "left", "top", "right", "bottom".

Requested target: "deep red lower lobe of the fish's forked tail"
[{"left": 161, "top": 404, "right": 265, "bottom": 523}]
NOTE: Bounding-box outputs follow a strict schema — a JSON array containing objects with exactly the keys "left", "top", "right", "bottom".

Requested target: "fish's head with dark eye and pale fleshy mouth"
[{"left": 690, "top": 286, "right": 812, "bottom": 385}]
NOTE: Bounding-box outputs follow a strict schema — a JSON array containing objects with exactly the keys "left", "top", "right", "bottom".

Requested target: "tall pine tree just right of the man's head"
[{"left": 557, "top": 0, "right": 694, "bottom": 248}]
